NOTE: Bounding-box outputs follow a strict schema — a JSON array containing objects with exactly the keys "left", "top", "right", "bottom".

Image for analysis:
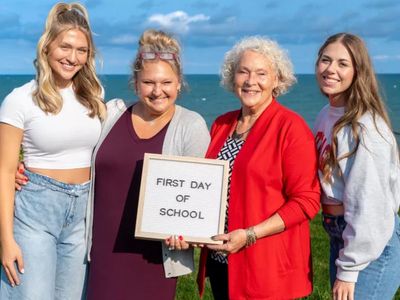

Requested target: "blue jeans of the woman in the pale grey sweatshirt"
[{"left": 323, "top": 214, "right": 400, "bottom": 300}]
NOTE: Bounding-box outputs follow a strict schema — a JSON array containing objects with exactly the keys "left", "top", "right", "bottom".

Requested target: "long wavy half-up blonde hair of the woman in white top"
[{"left": 33, "top": 3, "right": 106, "bottom": 120}]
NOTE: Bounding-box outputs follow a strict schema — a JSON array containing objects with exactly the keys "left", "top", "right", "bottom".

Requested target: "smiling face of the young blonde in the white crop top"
[{"left": 47, "top": 29, "right": 89, "bottom": 88}]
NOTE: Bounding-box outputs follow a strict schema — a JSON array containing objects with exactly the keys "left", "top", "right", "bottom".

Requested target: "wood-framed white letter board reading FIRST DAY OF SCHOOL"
[{"left": 135, "top": 153, "right": 229, "bottom": 244}]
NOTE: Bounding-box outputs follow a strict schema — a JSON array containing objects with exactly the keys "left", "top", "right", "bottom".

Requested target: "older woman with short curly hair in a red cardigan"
[{"left": 198, "top": 36, "right": 320, "bottom": 300}]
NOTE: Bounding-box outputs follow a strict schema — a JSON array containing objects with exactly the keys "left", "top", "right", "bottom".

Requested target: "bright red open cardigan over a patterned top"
[{"left": 197, "top": 100, "right": 320, "bottom": 300}]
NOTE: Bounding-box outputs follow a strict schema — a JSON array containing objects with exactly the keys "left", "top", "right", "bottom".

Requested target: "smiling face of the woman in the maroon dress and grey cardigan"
[{"left": 136, "top": 60, "right": 181, "bottom": 115}]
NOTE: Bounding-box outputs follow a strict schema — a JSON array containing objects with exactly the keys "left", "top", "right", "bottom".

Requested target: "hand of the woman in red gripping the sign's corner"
[{"left": 207, "top": 229, "right": 246, "bottom": 254}]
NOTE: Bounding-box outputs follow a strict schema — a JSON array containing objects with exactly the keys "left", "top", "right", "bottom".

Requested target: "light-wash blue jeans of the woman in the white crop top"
[{"left": 0, "top": 171, "right": 89, "bottom": 300}]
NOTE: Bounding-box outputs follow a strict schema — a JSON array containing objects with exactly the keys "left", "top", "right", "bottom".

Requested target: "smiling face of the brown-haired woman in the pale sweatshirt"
[{"left": 316, "top": 41, "right": 355, "bottom": 106}]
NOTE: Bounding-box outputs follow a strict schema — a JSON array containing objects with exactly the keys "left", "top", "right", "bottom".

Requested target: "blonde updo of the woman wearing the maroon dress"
[{"left": 130, "top": 29, "right": 187, "bottom": 91}]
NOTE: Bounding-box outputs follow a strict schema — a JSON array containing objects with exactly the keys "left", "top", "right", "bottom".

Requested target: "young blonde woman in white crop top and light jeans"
[{"left": 0, "top": 3, "right": 106, "bottom": 300}]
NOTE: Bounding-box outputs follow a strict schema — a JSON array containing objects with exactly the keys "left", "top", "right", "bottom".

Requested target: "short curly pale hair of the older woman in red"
[{"left": 221, "top": 36, "right": 296, "bottom": 97}]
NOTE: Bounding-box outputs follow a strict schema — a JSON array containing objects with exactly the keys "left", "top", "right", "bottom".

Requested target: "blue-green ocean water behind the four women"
[{"left": 0, "top": 74, "right": 400, "bottom": 141}]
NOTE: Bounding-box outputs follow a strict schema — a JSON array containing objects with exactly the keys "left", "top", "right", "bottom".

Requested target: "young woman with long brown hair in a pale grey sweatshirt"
[{"left": 315, "top": 33, "right": 400, "bottom": 300}]
